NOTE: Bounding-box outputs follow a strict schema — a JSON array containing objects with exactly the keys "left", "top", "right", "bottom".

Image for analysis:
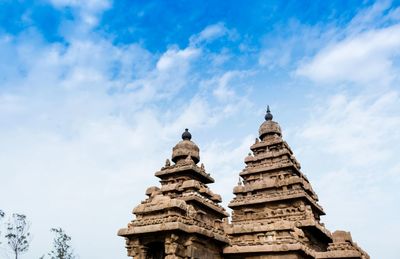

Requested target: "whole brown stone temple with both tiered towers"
[{"left": 118, "top": 108, "right": 369, "bottom": 259}]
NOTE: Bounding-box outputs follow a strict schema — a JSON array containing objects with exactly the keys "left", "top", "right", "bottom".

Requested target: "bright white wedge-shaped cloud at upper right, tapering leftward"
[{"left": 296, "top": 21, "right": 400, "bottom": 85}]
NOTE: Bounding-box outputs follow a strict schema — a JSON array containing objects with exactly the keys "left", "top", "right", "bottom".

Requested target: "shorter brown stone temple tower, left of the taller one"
[{"left": 118, "top": 129, "right": 229, "bottom": 259}]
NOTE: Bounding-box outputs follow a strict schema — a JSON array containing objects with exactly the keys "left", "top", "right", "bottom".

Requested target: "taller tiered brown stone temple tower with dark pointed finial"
[{"left": 224, "top": 107, "right": 368, "bottom": 259}]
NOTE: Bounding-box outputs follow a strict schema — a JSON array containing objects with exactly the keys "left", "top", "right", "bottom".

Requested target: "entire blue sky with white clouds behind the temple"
[{"left": 0, "top": 0, "right": 400, "bottom": 259}]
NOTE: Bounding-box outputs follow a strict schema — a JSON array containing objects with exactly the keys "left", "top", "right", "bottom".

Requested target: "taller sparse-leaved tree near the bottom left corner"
[{"left": 5, "top": 213, "right": 30, "bottom": 259}]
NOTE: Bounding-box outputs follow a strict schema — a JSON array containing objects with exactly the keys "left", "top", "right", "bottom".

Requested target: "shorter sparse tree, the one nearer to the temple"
[{"left": 49, "top": 228, "right": 75, "bottom": 259}]
